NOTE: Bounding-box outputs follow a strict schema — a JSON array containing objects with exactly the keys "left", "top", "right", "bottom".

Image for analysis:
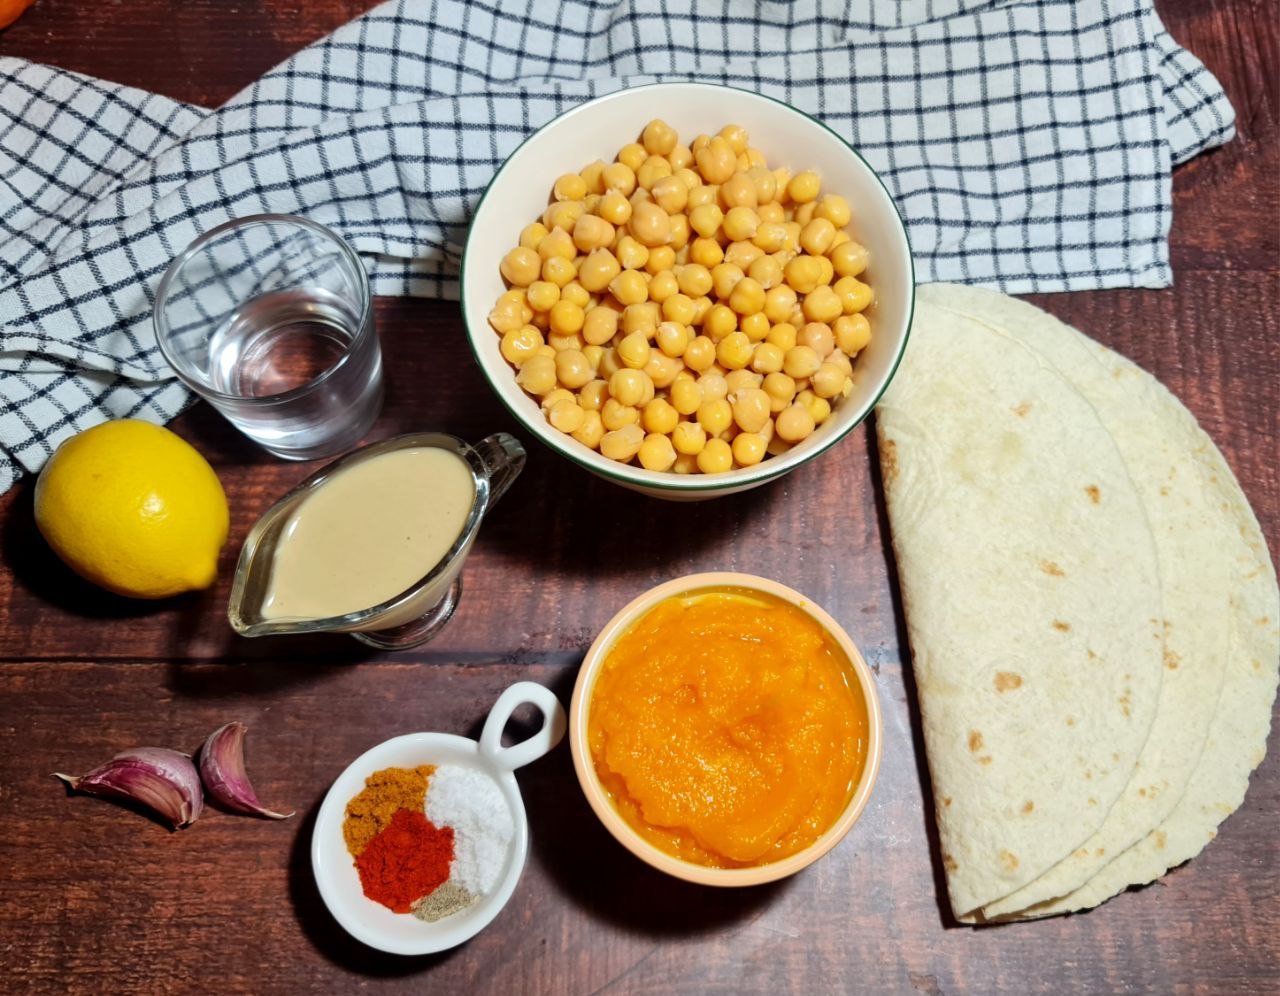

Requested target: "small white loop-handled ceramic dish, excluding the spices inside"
[{"left": 311, "top": 681, "right": 566, "bottom": 955}]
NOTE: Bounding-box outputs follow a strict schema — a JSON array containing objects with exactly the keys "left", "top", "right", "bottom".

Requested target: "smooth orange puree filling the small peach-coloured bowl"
[{"left": 588, "top": 589, "right": 868, "bottom": 868}]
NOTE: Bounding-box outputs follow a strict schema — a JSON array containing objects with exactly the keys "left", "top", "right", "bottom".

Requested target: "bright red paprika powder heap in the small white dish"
[{"left": 356, "top": 809, "right": 453, "bottom": 913}]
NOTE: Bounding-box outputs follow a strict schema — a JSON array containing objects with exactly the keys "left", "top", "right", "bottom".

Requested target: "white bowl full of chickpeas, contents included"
[{"left": 462, "top": 83, "right": 915, "bottom": 501}]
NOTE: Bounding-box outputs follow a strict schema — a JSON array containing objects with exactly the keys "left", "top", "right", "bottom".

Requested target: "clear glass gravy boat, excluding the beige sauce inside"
[{"left": 227, "top": 433, "right": 525, "bottom": 650}]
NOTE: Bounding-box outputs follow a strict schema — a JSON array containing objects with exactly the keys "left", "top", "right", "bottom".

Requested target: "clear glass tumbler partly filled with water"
[{"left": 155, "top": 215, "right": 383, "bottom": 460}]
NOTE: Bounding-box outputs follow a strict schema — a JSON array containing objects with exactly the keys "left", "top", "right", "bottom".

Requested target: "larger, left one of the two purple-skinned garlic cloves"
[{"left": 54, "top": 748, "right": 205, "bottom": 830}]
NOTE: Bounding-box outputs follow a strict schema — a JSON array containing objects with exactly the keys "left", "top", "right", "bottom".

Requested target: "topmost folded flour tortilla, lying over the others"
[{"left": 877, "top": 300, "right": 1165, "bottom": 917}]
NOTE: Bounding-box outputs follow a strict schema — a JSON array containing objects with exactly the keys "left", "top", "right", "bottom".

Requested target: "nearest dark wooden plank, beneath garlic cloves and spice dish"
[{"left": 0, "top": 659, "right": 1280, "bottom": 993}]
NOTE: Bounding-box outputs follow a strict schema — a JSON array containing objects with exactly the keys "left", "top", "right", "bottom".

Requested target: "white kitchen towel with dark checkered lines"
[{"left": 0, "top": 0, "right": 1233, "bottom": 490}]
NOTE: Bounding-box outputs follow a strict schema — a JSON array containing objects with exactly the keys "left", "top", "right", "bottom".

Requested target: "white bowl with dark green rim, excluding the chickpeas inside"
[{"left": 461, "top": 83, "right": 915, "bottom": 501}]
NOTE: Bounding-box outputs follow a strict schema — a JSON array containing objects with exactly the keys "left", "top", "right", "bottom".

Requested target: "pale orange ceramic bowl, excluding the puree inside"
[{"left": 568, "top": 572, "right": 883, "bottom": 886}]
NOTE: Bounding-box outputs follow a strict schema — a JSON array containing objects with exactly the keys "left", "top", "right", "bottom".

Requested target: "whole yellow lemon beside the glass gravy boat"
[{"left": 36, "top": 419, "right": 229, "bottom": 598}]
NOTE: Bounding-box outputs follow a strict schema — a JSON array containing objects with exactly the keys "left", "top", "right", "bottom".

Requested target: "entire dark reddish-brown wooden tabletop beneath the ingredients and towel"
[{"left": 0, "top": 0, "right": 1280, "bottom": 993}]
